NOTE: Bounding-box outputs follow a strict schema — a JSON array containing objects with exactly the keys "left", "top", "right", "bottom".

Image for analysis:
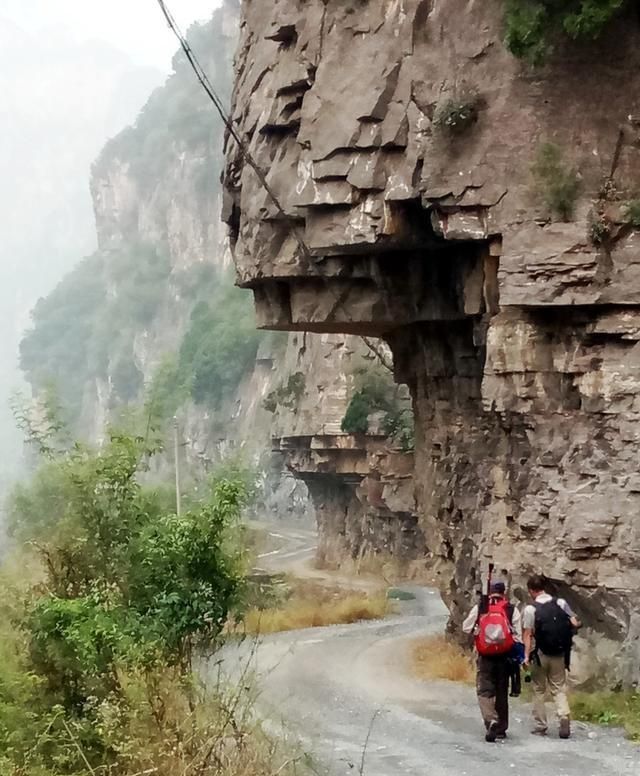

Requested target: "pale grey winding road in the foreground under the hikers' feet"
[{"left": 218, "top": 520, "right": 640, "bottom": 776}]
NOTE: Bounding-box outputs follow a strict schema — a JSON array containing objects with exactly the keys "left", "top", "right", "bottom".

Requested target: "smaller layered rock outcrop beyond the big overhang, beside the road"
[{"left": 271, "top": 334, "right": 420, "bottom": 576}]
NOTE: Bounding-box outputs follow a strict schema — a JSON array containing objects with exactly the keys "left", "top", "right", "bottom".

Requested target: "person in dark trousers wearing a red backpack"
[{"left": 462, "top": 580, "right": 522, "bottom": 743}]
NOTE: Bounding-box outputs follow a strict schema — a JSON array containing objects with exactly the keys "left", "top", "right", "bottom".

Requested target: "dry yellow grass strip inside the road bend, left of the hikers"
[{"left": 244, "top": 581, "right": 389, "bottom": 634}]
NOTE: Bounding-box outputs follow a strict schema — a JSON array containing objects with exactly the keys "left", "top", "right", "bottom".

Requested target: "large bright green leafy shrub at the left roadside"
[{"left": 13, "top": 434, "right": 245, "bottom": 684}]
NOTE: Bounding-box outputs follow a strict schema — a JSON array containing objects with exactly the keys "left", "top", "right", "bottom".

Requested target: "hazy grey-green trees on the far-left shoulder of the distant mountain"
[{"left": 20, "top": 244, "right": 170, "bottom": 416}]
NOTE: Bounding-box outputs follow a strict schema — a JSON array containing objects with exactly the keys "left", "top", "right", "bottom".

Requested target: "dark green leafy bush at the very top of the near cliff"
[{"left": 504, "top": 0, "right": 631, "bottom": 65}]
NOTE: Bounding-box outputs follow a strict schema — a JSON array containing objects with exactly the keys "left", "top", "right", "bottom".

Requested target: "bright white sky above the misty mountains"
[{"left": 0, "top": 0, "right": 220, "bottom": 71}]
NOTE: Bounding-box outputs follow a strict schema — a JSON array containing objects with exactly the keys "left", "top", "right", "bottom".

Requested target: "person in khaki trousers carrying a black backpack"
[{"left": 522, "top": 574, "right": 580, "bottom": 738}]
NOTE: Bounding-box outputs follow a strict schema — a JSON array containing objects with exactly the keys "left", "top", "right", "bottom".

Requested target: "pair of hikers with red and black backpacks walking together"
[{"left": 462, "top": 575, "right": 580, "bottom": 742}]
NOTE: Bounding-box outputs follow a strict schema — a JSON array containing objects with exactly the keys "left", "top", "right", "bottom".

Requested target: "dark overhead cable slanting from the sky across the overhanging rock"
[{"left": 157, "top": 0, "right": 393, "bottom": 371}]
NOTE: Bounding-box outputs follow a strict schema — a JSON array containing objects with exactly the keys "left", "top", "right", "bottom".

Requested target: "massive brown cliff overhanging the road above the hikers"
[{"left": 225, "top": 0, "right": 640, "bottom": 674}]
